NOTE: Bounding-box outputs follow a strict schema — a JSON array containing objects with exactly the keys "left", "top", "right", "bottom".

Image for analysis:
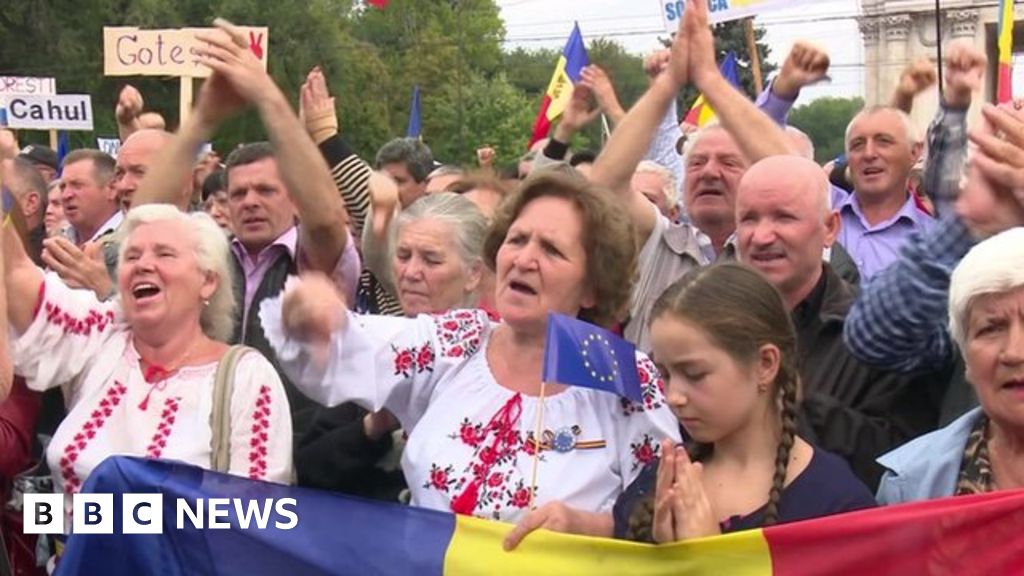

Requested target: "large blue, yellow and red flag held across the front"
[{"left": 57, "top": 457, "right": 1024, "bottom": 576}]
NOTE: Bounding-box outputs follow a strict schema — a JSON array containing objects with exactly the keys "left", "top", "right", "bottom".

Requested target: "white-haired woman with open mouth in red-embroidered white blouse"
[{"left": 3, "top": 205, "right": 292, "bottom": 510}]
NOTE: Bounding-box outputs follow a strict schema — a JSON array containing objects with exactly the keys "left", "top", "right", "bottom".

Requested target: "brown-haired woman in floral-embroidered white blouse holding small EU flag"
[{"left": 261, "top": 174, "right": 679, "bottom": 544}]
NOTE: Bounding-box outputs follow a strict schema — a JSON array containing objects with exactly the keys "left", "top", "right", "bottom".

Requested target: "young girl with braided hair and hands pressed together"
[{"left": 614, "top": 263, "right": 876, "bottom": 543}]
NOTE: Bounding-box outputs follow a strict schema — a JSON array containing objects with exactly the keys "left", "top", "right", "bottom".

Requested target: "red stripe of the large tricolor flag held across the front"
[{"left": 764, "top": 490, "right": 1024, "bottom": 576}]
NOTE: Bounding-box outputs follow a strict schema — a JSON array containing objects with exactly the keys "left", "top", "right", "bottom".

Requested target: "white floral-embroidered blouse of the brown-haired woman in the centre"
[{"left": 260, "top": 299, "right": 679, "bottom": 522}]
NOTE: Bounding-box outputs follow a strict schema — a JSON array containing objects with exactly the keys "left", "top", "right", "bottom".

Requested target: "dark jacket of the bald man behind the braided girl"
[{"left": 793, "top": 263, "right": 949, "bottom": 490}]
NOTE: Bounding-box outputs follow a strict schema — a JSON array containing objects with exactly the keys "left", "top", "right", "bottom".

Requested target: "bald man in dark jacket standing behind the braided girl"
[{"left": 736, "top": 156, "right": 948, "bottom": 488}]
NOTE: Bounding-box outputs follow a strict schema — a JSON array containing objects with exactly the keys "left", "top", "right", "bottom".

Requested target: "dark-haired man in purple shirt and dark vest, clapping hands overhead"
[{"left": 133, "top": 24, "right": 359, "bottom": 438}]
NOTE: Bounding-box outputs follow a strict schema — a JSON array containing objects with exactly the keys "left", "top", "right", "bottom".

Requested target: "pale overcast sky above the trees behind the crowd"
[{"left": 498, "top": 0, "right": 864, "bottom": 102}]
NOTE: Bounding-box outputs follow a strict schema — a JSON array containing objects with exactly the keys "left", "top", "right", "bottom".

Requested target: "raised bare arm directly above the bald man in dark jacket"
[{"left": 683, "top": 0, "right": 791, "bottom": 159}]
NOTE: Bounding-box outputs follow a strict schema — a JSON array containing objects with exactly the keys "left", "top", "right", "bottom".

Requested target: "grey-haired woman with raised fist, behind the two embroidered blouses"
[{"left": 362, "top": 177, "right": 487, "bottom": 317}]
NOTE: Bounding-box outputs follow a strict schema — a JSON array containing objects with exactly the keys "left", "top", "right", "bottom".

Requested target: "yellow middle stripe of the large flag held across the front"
[{"left": 444, "top": 516, "right": 772, "bottom": 576}]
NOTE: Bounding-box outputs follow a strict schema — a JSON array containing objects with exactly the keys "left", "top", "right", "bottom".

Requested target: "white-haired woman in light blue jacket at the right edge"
[{"left": 878, "top": 228, "right": 1024, "bottom": 504}]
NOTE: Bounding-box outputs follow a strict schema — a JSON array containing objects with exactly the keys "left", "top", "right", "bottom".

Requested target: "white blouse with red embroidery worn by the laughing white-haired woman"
[{"left": 11, "top": 274, "right": 292, "bottom": 510}]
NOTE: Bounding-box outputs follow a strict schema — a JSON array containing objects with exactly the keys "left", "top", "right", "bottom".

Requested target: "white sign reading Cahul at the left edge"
[{"left": 6, "top": 94, "right": 92, "bottom": 130}]
